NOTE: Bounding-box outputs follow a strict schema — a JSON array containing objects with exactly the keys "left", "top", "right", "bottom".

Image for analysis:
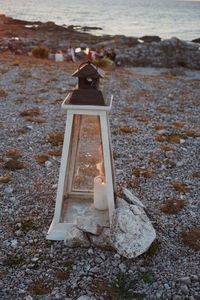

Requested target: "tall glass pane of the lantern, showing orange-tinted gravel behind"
[{"left": 71, "top": 115, "right": 105, "bottom": 192}]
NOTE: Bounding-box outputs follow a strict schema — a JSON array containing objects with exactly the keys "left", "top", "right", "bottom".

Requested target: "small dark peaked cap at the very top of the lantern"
[{"left": 72, "top": 61, "right": 103, "bottom": 78}]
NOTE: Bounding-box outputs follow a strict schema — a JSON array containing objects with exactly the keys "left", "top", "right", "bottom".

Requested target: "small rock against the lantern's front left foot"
[{"left": 64, "top": 226, "right": 90, "bottom": 248}]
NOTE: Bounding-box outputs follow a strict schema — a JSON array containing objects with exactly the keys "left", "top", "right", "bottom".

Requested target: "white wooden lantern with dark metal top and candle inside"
[{"left": 47, "top": 62, "right": 115, "bottom": 240}]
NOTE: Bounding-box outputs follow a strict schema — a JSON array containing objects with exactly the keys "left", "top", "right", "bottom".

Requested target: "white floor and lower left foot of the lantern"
[{"left": 47, "top": 197, "right": 110, "bottom": 241}]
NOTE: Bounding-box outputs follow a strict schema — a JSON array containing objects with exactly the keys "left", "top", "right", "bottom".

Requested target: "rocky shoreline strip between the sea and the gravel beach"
[{"left": 0, "top": 15, "right": 200, "bottom": 70}]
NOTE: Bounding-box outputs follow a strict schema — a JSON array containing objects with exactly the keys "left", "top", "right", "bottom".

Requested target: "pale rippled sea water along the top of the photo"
[{"left": 0, "top": 0, "right": 200, "bottom": 40}]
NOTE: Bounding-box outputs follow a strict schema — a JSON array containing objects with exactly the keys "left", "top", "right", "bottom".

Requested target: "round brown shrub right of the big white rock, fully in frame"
[{"left": 160, "top": 199, "right": 186, "bottom": 214}]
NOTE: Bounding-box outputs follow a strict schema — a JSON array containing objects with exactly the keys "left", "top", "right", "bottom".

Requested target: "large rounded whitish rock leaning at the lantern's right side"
[{"left": 111, "top": 205, "right": 156, "bottom": 258}]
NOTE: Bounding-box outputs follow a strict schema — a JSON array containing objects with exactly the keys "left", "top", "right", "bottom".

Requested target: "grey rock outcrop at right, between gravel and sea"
[{"left": 117, "top": 38, "right": 200, "bottom": 70}]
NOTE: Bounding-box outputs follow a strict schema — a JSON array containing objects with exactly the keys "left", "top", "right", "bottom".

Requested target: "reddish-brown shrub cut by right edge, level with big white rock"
[{"left": 181, "top": 228, "right": 200, "bottom": 250}]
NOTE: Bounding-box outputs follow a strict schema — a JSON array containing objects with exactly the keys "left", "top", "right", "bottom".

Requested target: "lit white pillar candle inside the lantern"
[{"left": 94, "top": 176, "right": 108, "bottom": 210}]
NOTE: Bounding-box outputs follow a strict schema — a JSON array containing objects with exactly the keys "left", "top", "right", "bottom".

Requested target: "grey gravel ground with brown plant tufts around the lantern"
[{"left": 0, "top": 56, "right": 200, "bottom": 300}]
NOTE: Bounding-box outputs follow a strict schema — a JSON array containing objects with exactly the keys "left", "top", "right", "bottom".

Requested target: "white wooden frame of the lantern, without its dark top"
[{"left": 47, "top": 94, "right": 115, "bottom": 240}]
